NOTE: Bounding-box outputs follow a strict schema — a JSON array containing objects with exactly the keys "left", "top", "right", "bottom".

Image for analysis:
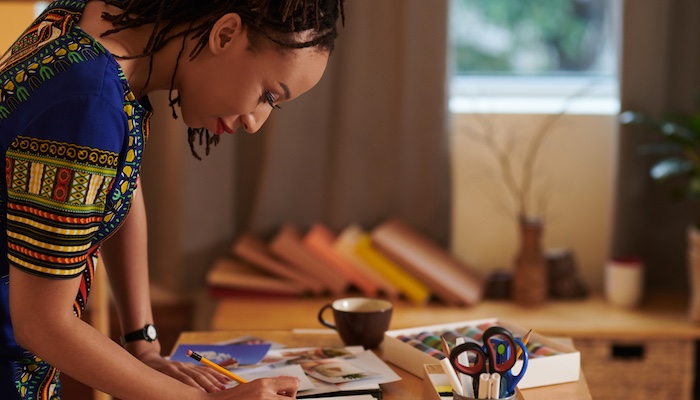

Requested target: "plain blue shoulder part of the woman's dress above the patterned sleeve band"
[{"left": 0, "top": 50, "right": 128, "bottom": 150}]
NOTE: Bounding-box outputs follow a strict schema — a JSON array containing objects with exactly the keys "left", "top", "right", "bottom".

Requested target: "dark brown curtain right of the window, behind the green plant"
[{"left": 612, "top": 0, "right": 700, "bottom": 292}]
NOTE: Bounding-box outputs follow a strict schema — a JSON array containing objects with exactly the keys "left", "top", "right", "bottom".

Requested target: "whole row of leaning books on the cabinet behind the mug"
[{"left": 207, "top": 219, "right": 484, "bottom": 305}]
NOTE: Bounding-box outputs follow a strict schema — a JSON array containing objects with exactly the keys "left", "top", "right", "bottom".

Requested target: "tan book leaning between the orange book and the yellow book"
[{"left": 333, "top": 224, "right": 401, "bottom": 299}]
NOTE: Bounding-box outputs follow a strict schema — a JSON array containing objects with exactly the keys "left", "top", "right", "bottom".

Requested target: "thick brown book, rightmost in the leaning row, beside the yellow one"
[{"left": 371, "top": 219, "right": 484, "bottom": 305}]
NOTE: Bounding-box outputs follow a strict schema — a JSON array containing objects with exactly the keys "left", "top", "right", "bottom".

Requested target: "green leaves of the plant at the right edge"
[{"left": 619, "top": 96, "right": 700, "bottom": 201}]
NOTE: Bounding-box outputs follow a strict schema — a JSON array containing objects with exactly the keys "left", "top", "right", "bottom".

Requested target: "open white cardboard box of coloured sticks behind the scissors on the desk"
[{"left": 382, "top": 318, "right": 581, "bottom": 389}]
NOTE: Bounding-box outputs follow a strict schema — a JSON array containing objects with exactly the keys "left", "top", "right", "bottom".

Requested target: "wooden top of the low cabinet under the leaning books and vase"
[{"left": 210, "top": 296, "right": 700, "bottom": 340}]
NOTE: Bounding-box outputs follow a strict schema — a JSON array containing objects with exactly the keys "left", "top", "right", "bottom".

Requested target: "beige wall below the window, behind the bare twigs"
[{"left": 451, "top": 114, "right": 616, "bottom": 290}]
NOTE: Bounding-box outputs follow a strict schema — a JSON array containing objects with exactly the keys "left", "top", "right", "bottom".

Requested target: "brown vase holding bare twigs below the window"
[{"left": 512, "top": 218, "right": 548, "bottom": 306}]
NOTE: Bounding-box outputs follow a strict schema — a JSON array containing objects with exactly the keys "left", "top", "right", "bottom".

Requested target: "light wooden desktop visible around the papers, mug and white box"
[{"left": 177, "top": 330, "right": 591, "bottom": 400}]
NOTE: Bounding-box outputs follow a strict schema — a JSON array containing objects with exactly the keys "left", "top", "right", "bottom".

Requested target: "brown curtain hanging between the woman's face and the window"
[{"left": 236, "top": 0, "right": 449, "bottom": 242}]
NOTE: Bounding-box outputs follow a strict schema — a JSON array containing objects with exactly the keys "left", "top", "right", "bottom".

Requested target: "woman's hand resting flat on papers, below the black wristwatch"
[{"left": 133, "top": 351, "right": 231, "bottom": 393}]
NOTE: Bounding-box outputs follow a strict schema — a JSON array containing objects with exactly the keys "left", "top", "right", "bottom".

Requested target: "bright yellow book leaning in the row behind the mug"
[{"left": 355, "top": 233, "right": 430, "bottom": 305}]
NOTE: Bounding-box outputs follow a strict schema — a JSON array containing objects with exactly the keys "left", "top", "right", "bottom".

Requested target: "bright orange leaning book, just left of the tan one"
[{"left": 303, "top": 222, "right": 378, "bottom": 297}]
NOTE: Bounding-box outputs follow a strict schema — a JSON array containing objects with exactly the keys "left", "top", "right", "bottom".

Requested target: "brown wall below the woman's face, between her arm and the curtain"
[{"left": 141, "top": 91, "right": 235, "bottom": 294}]
